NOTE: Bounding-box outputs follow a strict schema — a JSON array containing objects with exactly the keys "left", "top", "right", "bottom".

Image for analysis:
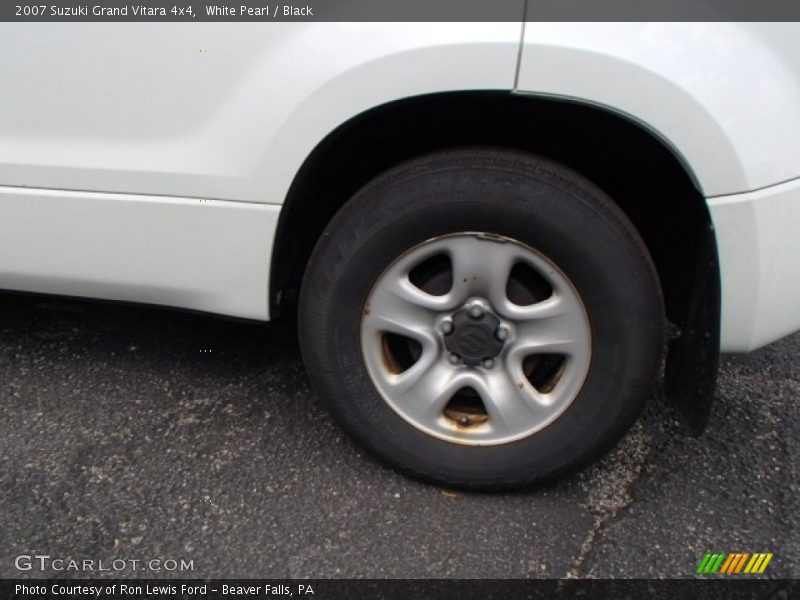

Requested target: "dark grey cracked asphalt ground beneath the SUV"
[{"left": 0, "top": 293, "right": 800, "bottom": 578}]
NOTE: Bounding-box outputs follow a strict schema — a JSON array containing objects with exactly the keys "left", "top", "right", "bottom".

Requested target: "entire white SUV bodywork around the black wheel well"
[{"left": 0, "top": 23, "right": 800, "bottom": 488}]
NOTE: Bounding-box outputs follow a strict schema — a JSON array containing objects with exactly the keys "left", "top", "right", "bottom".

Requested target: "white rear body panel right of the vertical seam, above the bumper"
[{"left": 518, "top": 23, "right": 800, "bottom": 196}]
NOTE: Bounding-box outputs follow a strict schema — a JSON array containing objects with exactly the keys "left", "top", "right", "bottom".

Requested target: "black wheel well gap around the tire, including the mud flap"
[{"left": 270, "top": 91, "right": 720, "bottom": 433}]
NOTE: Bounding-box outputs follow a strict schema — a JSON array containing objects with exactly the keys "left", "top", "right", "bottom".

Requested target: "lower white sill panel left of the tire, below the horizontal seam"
[{"left": 0, "top": 187, "right": 280, "bottom": 319}]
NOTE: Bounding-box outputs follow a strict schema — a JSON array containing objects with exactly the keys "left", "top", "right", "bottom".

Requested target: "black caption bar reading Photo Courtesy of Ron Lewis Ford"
[{"left": 0, "top": 576, "right": 800, "bottom": 600}]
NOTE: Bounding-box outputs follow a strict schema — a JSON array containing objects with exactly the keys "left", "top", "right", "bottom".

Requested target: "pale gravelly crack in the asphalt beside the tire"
[{"left": 564, "top": 420, "right": 652, "bottom": 579}]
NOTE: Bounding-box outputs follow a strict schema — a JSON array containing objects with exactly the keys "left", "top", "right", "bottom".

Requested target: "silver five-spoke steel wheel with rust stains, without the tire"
[{"left": 361, "top": 232, "right": 592, "bottom": 446}]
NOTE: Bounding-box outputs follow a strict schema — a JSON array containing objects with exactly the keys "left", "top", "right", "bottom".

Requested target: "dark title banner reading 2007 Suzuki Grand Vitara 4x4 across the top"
[{"left": 0, "top": 0, "right": 800, "bottom": 22}]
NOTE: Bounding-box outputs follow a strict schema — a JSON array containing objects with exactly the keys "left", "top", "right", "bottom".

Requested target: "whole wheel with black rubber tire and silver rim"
[{"left": 298, "top": 149, "right": 665, "bottom": 490}]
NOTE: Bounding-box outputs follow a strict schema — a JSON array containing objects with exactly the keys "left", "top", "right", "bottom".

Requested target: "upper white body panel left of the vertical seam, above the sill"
[{"left": 0, "top": 23, "right": 522, "bottom": 204}]
